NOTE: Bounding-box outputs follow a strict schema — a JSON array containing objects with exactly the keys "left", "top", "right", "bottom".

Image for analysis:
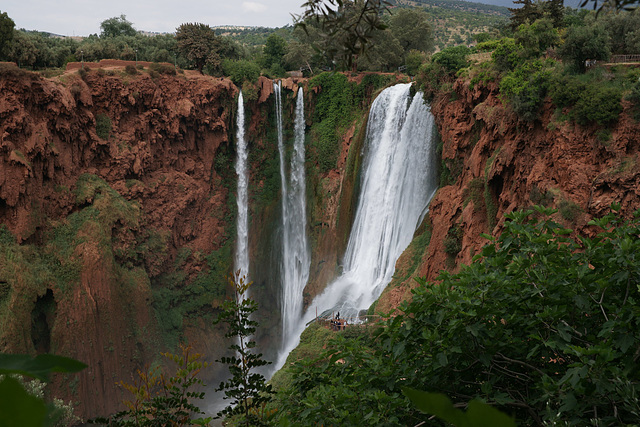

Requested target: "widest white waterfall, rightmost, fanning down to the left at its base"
[{"left": 277, "top": 84, "right": 438, "bottom": 368}]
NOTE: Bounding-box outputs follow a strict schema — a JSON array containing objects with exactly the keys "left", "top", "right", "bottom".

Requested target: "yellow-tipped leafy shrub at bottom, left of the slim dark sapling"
[{"left": 92, "top": 346, "right": 211, "bottom": 427}]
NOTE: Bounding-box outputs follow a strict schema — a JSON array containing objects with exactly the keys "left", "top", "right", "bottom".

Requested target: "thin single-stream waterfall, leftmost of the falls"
[{"left": 235, "top": 91, "right": 249, "bottom": 281}]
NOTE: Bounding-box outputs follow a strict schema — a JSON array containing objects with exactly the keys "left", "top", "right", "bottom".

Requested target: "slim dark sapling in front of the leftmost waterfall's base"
[{"left": 214, "top": 277, "right": 273, "bottom": 426}]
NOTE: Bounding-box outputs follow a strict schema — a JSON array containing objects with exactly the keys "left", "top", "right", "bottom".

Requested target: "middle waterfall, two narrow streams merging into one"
[{"left": 274, "top": 84, "right": 311, "bottom": 348}]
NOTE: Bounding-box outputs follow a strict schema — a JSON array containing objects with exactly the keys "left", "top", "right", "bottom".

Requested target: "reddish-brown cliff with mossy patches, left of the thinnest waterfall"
[{"left": 0, "top": 66, "right": 237, "bottom": 417}]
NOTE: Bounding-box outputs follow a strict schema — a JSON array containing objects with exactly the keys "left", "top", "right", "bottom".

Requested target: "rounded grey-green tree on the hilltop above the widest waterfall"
[{"left": 389, "top": 9, "right": 433, "bottom": 56}]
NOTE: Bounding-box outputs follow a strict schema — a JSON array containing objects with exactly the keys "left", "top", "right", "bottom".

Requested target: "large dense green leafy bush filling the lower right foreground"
[{"left": 279, "top": 206, "right": 640, "bottom": 425}]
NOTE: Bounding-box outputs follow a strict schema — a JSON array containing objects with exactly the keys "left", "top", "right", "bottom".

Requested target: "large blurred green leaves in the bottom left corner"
[{"left": 0, "top": 354, "right": 87, "bottom": 427}]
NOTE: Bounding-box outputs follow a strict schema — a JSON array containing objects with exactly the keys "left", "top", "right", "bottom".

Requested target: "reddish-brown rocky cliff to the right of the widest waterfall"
[{"left": 377, "top": 79, "right": 640, "bottom": 311}]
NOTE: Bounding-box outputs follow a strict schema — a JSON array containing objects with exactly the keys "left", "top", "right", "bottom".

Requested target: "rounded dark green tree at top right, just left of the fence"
[{"left": 558, "top": 24, "right": 610, "bottom": 72}]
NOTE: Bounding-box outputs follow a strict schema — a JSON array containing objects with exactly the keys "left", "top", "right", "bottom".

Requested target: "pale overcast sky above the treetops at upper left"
[{"left": 0, "top": 0, "right": 305, "bottom": 36}]
